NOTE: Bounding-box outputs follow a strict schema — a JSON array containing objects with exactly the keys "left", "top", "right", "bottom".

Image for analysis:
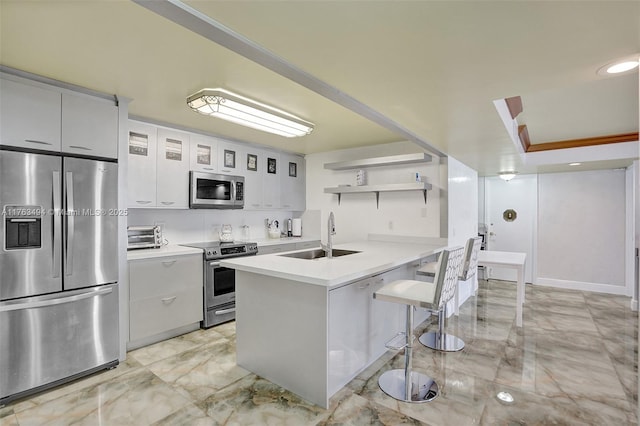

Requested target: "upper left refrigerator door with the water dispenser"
[{"left": 0, "top": 151, "right": 62, "bottom": 300}]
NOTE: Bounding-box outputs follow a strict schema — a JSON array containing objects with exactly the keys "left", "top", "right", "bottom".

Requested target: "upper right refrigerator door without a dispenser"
[{"left": 63, "top": 158, "right": 118, "bottom": 290}]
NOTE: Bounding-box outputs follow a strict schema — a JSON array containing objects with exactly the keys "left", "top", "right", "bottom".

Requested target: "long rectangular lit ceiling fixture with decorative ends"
[{"left": 187, "top": 88, "right": 314, "bottom": 138}]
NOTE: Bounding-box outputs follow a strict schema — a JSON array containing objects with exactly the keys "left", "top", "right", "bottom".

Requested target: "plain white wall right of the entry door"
[{"left": 537, "top": 170, "right": 630, "bottom": 295}]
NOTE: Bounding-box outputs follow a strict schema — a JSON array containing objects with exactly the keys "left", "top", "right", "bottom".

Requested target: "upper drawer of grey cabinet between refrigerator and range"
[{"left": 129, "top": 255, "right": 203, "bottom": 301}]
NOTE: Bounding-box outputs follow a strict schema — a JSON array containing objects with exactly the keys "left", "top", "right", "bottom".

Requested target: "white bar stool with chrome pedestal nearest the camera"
[{"left": 373, "top": 247, "right": 464, "bottom": 402}]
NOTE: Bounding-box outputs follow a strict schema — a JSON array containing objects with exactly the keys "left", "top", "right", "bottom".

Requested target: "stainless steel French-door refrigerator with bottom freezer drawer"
[{"left": 0, "top": 148, "right": 119, "bottom": 406}]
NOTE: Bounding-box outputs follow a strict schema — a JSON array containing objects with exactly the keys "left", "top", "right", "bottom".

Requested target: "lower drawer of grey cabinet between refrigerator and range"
[{"left": 129, "top": 288, "right": 203, "bottom": 340}]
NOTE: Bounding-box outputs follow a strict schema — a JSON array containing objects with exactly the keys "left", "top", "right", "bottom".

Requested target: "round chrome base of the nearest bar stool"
[{"left": 378, "top": 369, "right": 438, "bottom": 402}]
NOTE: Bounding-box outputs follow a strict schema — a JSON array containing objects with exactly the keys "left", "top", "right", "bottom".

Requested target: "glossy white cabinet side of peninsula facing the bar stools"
[{"left": 329, "top": 265, "right": 419, "bottom": 395}]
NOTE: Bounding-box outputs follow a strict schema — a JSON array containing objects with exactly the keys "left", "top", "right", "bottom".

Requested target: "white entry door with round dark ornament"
[{"left": 485, "top": 175, "right": 538, "bottom": 283}]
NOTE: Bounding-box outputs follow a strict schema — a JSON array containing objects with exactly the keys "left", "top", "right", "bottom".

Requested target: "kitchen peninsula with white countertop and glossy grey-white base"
[{"left": 221, "top": 241, "right": 444, "bottom": 408}]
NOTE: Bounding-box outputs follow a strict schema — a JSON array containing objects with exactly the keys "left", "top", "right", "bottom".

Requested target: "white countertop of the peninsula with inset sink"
[{"left": 220, "top": 241, "right": 444, "bottom": 287}]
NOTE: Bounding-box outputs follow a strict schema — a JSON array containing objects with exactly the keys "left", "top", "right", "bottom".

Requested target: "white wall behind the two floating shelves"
[{"left": 305, "top": 142, "right": 442, "bottom": 243}]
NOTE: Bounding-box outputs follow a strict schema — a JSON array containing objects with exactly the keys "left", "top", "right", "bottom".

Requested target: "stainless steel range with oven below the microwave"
[{"left": 181, "top": 241, "right": 258, "bottom": 328}]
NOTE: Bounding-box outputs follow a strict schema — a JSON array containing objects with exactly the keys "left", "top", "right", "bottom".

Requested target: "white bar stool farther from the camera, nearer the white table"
[{"left": 416, "top": 237, "right": 482, "bottom": 352}]
